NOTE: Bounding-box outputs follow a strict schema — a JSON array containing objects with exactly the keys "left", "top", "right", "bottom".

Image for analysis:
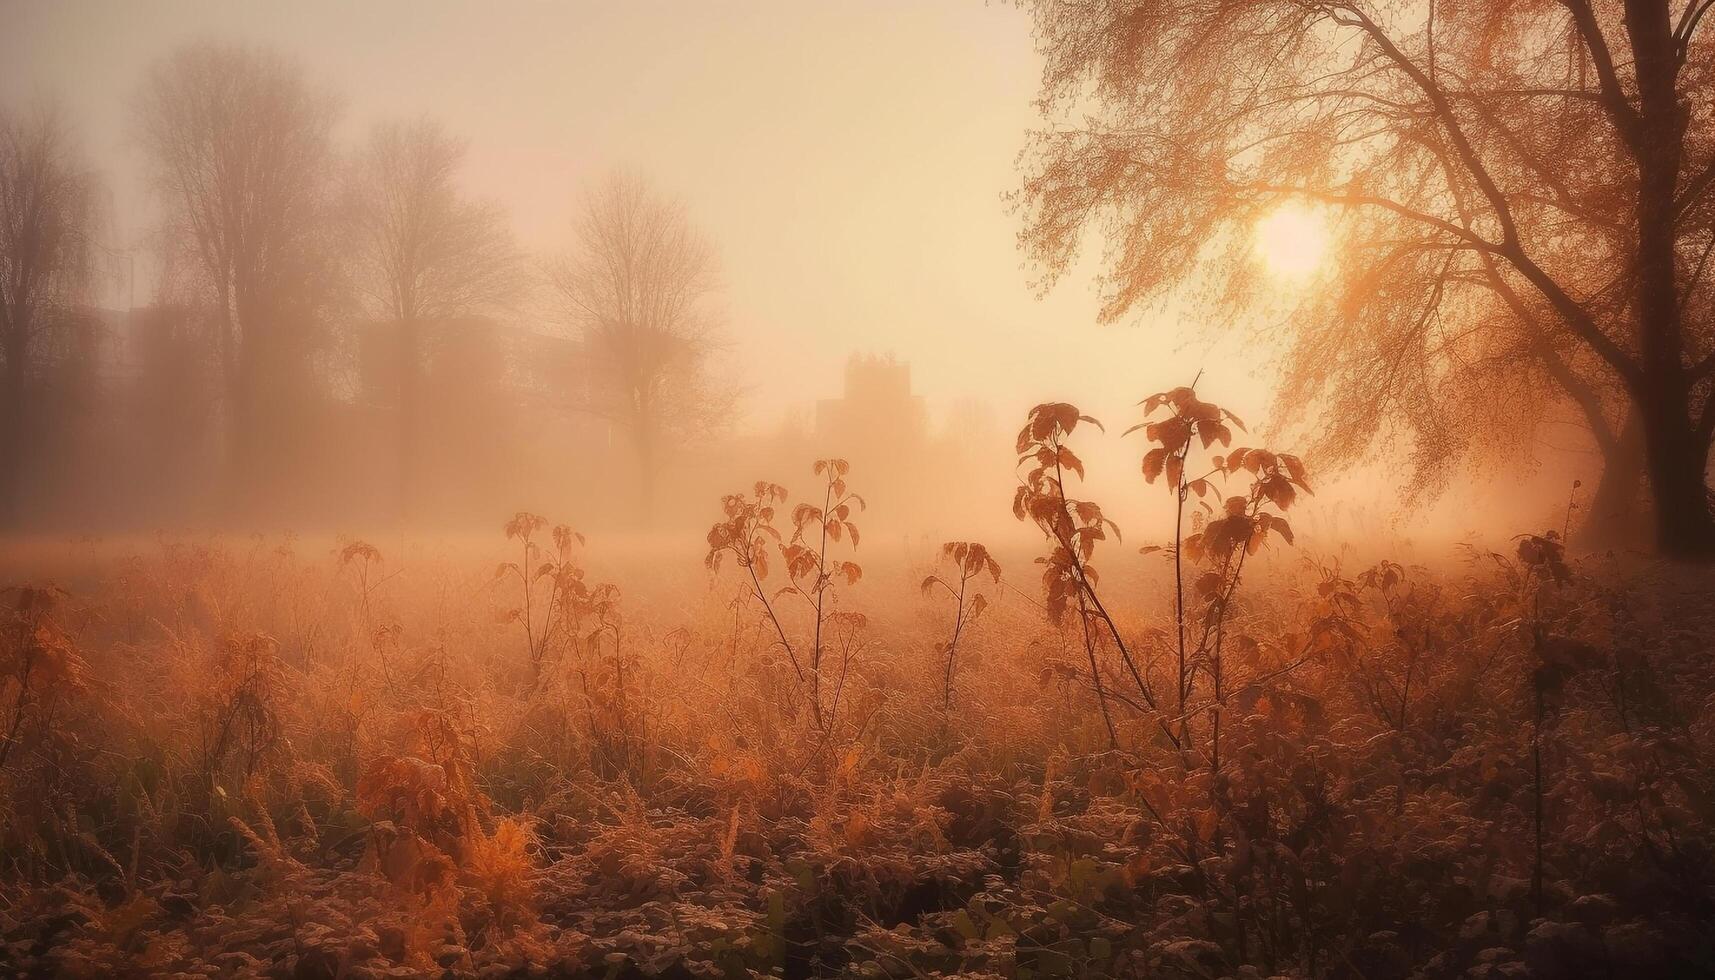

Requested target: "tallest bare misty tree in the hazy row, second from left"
[{"left": 135, "top": 43, "right": 334, "bottom": 511}]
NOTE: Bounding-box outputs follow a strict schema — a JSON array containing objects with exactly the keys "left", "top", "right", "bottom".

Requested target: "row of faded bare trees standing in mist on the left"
[{"left": 0, "top": 43, "right": 731, "bottom": 529}]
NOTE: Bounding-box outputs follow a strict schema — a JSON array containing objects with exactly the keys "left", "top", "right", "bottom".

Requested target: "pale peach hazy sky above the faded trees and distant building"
[{"left": 0, "top": 0, "right": 1282, "bottom": 427}]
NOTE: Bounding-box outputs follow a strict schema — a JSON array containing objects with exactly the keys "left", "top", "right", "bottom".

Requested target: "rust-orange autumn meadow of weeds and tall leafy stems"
[{"left": 0, "top": 390, "right": 1715, "bottom": 980}]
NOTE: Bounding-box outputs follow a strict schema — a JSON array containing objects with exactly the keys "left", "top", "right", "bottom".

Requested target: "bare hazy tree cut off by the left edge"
[{"left": 0, "top": 105, "right": 98, "bottom": 523}]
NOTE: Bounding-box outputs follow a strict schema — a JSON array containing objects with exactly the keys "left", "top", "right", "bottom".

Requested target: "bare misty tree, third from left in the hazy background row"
[{"left": 348, "top": 120, "right": 521, "bottom": 515}]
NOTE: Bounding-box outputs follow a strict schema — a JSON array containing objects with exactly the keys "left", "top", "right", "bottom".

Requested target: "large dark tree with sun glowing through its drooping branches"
[{"left": 1020, "top": 0, "right": 1715, "bottom": 558}]
